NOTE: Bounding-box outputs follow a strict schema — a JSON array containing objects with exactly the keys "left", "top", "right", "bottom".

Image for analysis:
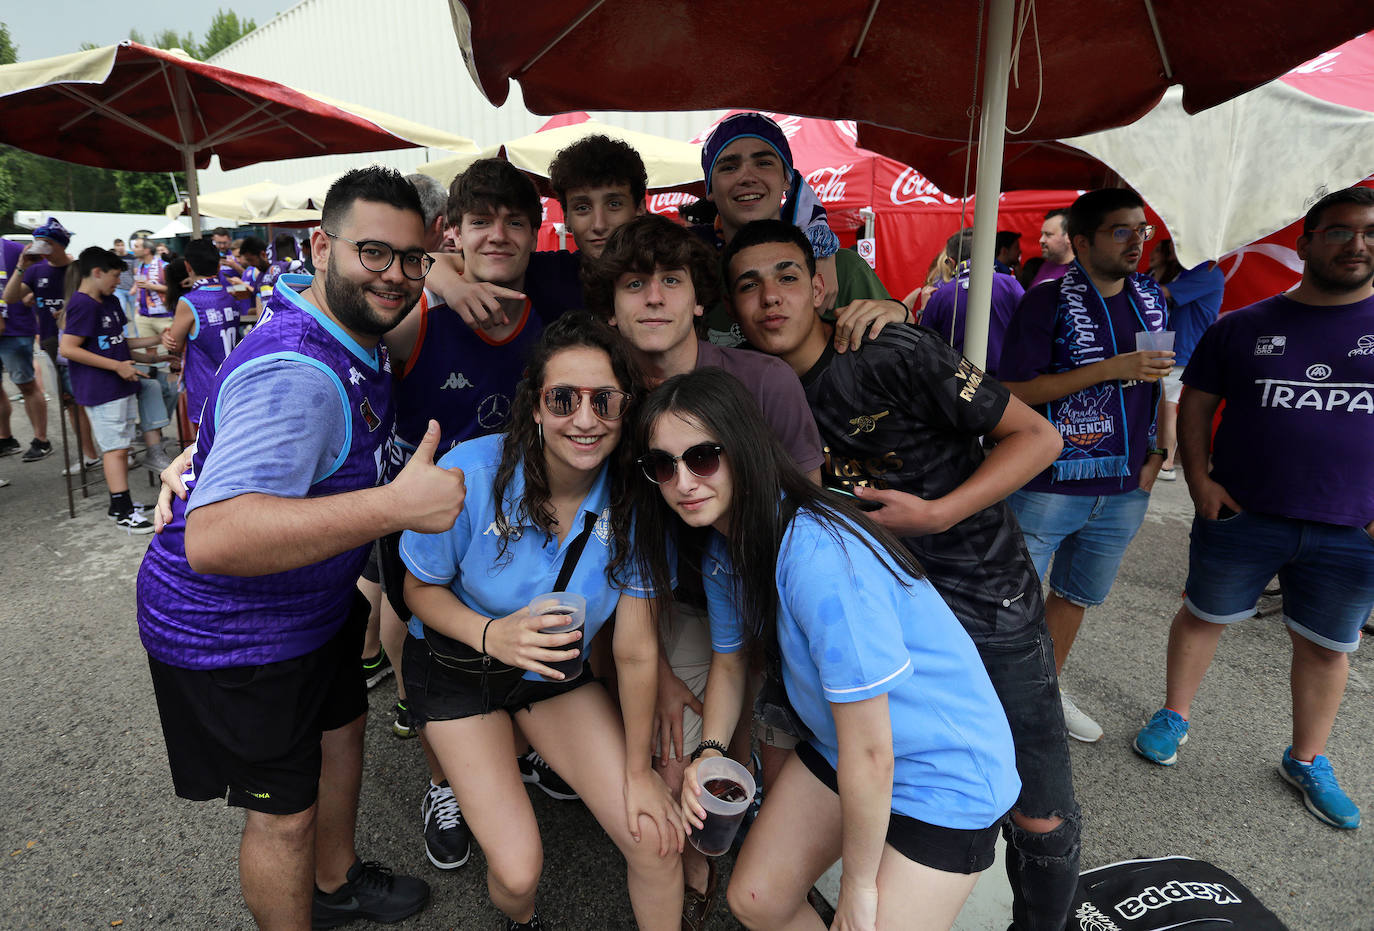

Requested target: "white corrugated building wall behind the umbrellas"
[{"left": 199, "top": 0, "right": 723, "bottom": 192}]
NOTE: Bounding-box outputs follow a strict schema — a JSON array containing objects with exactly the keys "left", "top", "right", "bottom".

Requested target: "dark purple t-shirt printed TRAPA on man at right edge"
[{"left": 1183, "top": 295, "right": 1374, "bottom": 527}]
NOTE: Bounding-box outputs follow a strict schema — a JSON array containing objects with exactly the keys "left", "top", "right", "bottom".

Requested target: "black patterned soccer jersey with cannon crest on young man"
[{"left": 801, "top": 325, "right": 1044, "bottom": 645}]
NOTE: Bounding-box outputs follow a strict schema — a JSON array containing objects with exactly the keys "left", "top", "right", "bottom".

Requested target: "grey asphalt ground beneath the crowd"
[{"left": 0, "top": 383, "right": 1374, "bottom": 931}]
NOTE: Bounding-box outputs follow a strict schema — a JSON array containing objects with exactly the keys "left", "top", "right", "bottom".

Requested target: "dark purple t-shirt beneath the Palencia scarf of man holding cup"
[{"left": 998, "top": 280, "right": 1156, "bottom": 494}]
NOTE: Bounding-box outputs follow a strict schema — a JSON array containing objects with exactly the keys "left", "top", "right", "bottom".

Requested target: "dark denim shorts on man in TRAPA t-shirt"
[{"left": 1183, "top": 511, "right": 1374, "bottom": 652}]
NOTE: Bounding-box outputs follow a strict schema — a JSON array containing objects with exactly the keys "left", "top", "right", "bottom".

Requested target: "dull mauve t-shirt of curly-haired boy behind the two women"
[{"left": 697, "top": 341, "right": 826, "bottom": 472}]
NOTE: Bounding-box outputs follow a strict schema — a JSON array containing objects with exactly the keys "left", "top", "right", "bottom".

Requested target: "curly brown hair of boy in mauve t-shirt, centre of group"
[{"left": 581, "top": 213, "right": 721, "bottom": 321}]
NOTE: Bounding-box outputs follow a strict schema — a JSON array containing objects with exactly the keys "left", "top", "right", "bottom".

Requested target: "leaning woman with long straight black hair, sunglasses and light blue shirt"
[{"left": 635, "top": 369, "right": 1021, "bottom": 931}]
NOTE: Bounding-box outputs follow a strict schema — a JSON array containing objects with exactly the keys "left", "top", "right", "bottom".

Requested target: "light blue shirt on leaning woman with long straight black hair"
[{"left": 703, "top": 511, "right": 1021, "bottom": 829}]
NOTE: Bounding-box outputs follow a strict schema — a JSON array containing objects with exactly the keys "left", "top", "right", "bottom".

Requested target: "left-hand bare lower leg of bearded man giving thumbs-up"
[{"left": 239, "top": 806, "right": 315, "bottom": 931}]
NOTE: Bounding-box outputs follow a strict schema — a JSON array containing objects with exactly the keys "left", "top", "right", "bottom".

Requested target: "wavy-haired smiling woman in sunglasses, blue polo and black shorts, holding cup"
[{"left": 401, "top": 313, "right": 683, "bottom": 928}]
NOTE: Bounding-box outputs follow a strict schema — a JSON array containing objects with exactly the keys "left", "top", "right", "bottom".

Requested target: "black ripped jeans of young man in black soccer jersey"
[{"left": 977, "top": 631, "right": 1083, "bottom": 931}]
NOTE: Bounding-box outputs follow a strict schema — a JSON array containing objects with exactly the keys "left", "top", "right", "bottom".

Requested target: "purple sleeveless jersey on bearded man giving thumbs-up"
[{"left": 139, "top": 276, "right": 392, "bottom": 669}]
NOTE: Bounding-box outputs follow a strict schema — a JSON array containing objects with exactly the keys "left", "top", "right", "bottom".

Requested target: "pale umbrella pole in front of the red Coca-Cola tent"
[{"left": 963, "top": 0, "right": 1015, "bottom": 368}]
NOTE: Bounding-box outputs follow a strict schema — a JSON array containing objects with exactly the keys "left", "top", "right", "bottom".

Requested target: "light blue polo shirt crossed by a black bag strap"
[{"left": 401, "top": 434, "right": 649, "bottom": 681}]
